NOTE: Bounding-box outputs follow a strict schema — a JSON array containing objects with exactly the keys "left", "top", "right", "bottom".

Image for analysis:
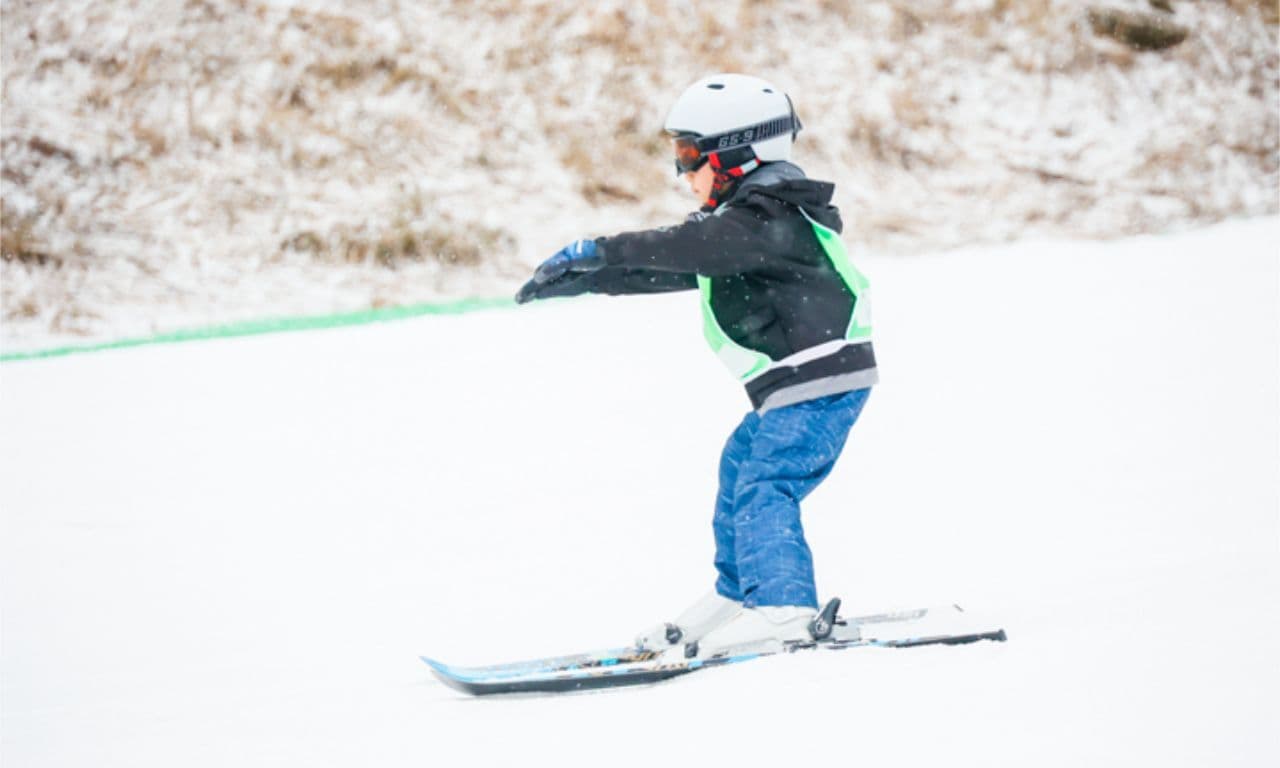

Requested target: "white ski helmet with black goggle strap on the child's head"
[{"left": 663, "top": 73, "right": 803, "bottom": 173}]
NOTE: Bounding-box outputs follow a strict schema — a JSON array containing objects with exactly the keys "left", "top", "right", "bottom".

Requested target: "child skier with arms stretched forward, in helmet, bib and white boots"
[{"left": 516, "top": 74, "right": 877, "bottom": 658}]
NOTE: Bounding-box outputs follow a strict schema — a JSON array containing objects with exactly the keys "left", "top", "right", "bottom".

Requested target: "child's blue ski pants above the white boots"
[{"left": 712, "top": 389, "right": 870, "bottom": 608}]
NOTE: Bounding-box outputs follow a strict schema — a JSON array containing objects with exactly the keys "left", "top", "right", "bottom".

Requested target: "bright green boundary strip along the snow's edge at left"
[{"left": 0, "top": 298, "right": 516, "bottom": 362}]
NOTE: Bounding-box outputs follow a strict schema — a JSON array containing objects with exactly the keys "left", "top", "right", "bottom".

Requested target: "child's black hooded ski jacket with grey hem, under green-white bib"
[{"left": 524, "top": 163, "right": 877, "bottom": 412}]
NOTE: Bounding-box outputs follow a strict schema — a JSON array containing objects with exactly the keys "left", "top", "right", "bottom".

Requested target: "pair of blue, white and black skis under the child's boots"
[{"left": 422, "top": 600, "right": 1006, "bottom": 696}]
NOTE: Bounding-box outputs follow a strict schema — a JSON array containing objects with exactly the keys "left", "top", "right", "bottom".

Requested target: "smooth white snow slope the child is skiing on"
[{"left": 0, "top": 218, "right": 1280, "bottom": 768}]
